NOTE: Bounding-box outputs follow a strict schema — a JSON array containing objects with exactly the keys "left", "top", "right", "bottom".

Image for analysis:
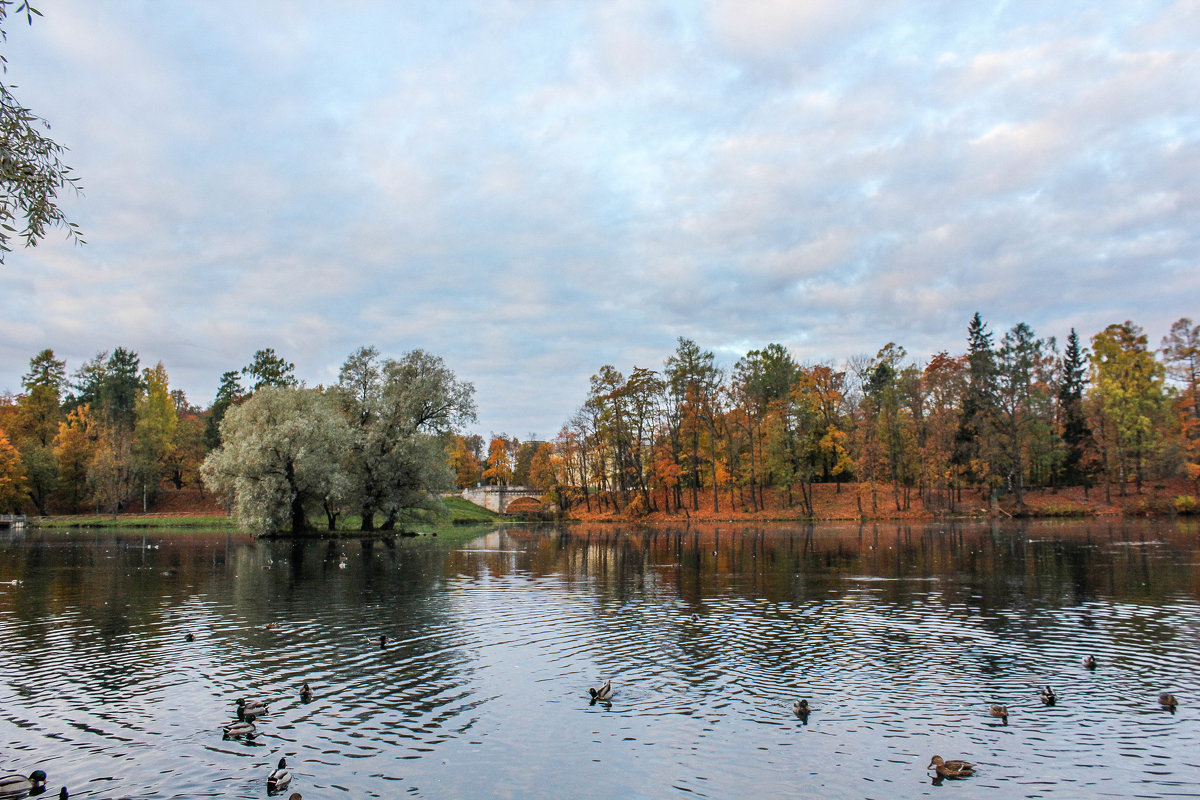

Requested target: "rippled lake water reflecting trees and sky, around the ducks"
[{"left": 0, "top": 521, "right": 1200, "bottom": 798}]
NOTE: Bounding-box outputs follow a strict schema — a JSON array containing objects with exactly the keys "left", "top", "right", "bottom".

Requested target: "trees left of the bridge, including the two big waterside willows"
[{"left": 0, "top": 348, "right": 475, "bottom": 531}]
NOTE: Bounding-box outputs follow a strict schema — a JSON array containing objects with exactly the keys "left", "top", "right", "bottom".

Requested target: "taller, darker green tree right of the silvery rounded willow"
[{"left": 331, "top": 347, "right": 475, "bottom": 530}]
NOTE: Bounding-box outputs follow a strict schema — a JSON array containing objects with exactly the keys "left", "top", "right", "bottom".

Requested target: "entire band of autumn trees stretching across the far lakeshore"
[{"left": 0, "top": 314, "right": 1200, "bottom": 531}]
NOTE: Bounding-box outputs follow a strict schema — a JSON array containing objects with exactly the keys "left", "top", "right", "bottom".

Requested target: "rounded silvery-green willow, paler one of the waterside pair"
[{"left": 200, "top": 387, "right": 352, "bottom": 535}]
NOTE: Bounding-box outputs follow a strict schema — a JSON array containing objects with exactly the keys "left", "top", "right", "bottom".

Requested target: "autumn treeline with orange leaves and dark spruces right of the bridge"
[{"left": 523, "top": 314, "right": 1200, "bottom": 515}]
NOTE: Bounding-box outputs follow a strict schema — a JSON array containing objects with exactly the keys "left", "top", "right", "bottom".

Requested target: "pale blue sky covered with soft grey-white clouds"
[{"left": 0, "top": 0, "right": 1200, "bottom": 439}]
